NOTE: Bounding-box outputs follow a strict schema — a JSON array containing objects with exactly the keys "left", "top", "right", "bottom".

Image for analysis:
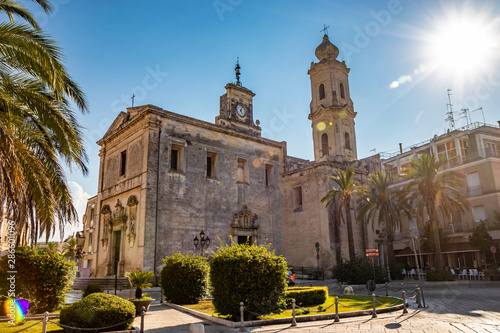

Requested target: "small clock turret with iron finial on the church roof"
[{"left": 215, "top": 61, "right": 261, "bottom": 136}]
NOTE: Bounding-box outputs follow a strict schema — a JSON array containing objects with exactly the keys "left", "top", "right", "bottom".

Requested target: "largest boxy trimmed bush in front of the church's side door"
[{"left": 210, "top": 243, "right": 288, "bottom": 317}]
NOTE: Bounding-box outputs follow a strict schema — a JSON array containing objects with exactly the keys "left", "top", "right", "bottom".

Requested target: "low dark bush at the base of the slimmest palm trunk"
[{"left": 333, "top": 257, "right": 386, "bottom": 284}]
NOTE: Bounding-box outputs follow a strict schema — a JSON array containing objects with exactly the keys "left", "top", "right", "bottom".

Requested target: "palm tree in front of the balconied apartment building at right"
[{"left": 401, "top": 154, "right": 469, "bottom": 269}]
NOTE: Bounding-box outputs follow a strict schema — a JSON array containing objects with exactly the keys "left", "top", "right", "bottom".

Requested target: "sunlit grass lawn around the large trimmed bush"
[{"left": 183, "top": 296, "right": 403, "bottom": 319}]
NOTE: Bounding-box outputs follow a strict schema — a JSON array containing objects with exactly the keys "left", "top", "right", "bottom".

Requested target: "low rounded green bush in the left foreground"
[{"left": 60, "top": 293, "right": 135, "bottom": 332}]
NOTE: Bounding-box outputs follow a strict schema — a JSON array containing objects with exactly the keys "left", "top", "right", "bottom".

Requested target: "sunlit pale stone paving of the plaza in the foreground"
[{"left": 134, "top": 280, "right": 500, "bottom": 333}]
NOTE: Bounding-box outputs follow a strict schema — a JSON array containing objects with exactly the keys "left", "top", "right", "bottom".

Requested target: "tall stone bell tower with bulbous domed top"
[{"left": 307, "top": 34, "right": 357, "bottom": 161}]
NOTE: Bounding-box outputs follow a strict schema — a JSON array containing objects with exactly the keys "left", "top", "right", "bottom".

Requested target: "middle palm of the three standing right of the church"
[{"left": 357, "top": 171, "right": 410, "bottom": 263}]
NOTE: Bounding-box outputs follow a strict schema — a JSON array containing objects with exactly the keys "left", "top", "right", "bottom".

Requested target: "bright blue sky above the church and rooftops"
[{"left": 26, "top": 0, "right": 500, "bottom": 235}]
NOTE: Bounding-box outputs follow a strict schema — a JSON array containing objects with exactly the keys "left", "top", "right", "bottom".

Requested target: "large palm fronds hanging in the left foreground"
[{"left": 0, "top": 0, "right": 87, "bottom": 242}]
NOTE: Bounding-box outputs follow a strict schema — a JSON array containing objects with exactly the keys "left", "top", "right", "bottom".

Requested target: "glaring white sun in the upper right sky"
[{"left": 426, "top": 11, "right": 499, "bottom": 81}]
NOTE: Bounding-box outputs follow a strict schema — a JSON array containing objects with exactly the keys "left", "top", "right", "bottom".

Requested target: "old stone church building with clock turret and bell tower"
[{"left": 82, "top": 35, "right": 380, "bottom": 276}]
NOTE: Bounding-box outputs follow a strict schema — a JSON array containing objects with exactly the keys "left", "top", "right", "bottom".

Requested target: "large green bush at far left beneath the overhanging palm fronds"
[{"left": 0, "top": 246, "right": 76, "bottom": 313}]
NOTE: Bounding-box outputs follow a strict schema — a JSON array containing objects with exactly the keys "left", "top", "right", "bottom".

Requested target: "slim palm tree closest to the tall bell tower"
[{"left": 321, "top": 167, "right": 361, "bottom": 260}]
